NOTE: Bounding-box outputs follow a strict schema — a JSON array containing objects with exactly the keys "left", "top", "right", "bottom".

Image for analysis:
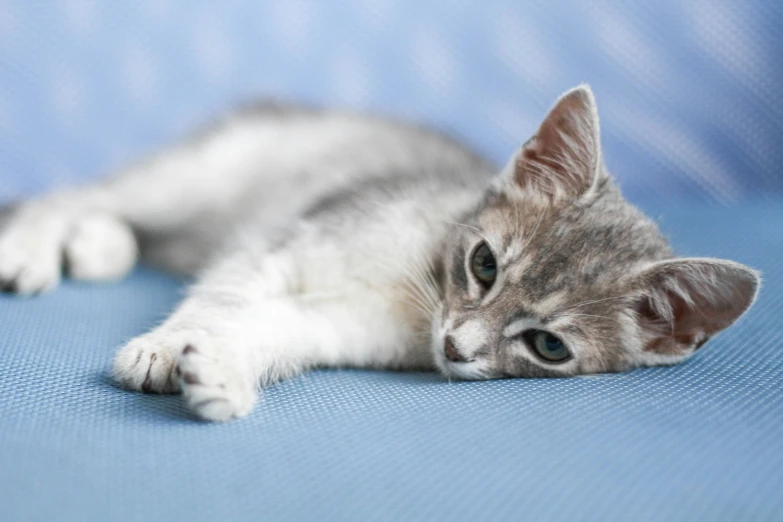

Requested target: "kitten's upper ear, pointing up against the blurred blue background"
[{"left": 505, "top": 85, "right": 603, "bottom": 201}]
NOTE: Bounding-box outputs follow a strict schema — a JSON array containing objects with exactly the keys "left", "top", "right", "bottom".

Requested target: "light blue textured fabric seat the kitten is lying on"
[{"left": 0, "top": 202, "right": 783, "bottom": 521}]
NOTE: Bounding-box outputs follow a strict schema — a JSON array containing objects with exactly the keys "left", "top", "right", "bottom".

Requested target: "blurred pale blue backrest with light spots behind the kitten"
[{"left": 0, "top": 0, "right": 783, "bottom": 202}]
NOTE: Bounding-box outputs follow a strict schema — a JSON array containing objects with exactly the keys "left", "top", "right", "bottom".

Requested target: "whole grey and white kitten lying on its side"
[{"left": 0, "top": 86, "right": 759, "bottom": 420}]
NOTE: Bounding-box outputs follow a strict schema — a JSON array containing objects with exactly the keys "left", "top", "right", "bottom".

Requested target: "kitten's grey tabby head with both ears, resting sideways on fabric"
[{"left": 432, "top": 86, "right": 759, "bottom": 378}]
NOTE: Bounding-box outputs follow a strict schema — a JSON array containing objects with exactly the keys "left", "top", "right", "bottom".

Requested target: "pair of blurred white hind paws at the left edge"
[{"left": 0, "top": 201, "right": 138, "bottom": 295}]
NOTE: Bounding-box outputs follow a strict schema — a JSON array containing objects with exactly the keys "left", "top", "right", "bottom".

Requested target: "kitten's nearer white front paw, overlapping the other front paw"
[{"left": 176, "top": 341, "right": 258, "bottom": 421}]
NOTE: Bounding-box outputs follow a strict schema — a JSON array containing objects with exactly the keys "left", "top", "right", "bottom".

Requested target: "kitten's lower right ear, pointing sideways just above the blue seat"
[{"left": 632, "top": 258, "right": 761, "bottom": 365}]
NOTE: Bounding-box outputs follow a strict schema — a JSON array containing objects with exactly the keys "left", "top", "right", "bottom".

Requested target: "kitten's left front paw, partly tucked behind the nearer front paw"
[{"left": 113, "top": 332, "right": 181, "bottom": 393}]
